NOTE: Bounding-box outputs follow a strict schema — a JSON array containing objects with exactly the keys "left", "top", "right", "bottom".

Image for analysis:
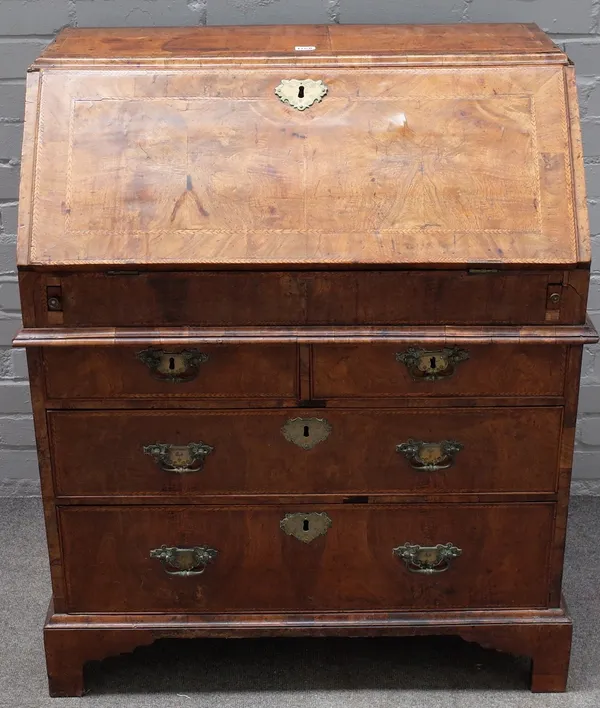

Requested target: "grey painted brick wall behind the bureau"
[{"left": 0, "top": 0, "right": 600, "bottom": 486}]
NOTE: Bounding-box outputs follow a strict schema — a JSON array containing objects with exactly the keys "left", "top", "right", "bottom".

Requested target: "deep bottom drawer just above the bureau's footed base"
[{"left": 59, "top": 503, "right": 554, "bottom": 613}]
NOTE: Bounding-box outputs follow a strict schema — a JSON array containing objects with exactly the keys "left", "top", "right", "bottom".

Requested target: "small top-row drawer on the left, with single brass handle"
[{"left": 44, "top": 345, "right": 298, "bottom": 399}]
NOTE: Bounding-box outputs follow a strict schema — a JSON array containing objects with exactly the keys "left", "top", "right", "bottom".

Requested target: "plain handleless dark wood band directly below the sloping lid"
[{"left": 28, "top": 270, "right": 585, "bottom": 327}]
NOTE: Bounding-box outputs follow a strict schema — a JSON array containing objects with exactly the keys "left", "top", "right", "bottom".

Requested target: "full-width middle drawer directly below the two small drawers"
[{"left": 48, "top": 408, "right": 562, "bottom": 497}]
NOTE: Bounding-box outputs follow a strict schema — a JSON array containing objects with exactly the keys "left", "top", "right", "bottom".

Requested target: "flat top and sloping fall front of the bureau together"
[{"left": 18, "top": 25, "right": 589, "bottom": 268}]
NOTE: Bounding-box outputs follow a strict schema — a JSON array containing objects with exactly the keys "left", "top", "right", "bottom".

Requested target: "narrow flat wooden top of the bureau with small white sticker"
[{"left": 36, "top": 23, "right": 565, "bottom": 66}]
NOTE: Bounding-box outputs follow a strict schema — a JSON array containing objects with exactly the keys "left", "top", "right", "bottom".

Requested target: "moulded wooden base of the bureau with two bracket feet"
[{"left": 44, "top": 603, "right": 572, "bottom": 696}]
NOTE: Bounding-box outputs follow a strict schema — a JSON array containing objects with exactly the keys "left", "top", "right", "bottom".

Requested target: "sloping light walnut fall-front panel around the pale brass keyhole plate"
[{"left": 21, "top": 66, "right": 577, "bottom": 267}]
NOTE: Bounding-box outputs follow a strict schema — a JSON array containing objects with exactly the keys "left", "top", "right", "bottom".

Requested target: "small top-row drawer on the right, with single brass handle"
[{"left": 312, "top": 342, "right": 566, "bottom": 399}]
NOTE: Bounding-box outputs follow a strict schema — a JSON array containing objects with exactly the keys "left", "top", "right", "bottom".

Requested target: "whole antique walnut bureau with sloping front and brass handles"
[{"left": 15, "top": 25, "right": 596, "bottom": 696}]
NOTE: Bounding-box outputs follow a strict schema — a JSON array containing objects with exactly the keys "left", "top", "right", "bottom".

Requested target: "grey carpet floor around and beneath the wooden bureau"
[{"left": 0, "top": 497, "right": 600, "bottom": 708}]
